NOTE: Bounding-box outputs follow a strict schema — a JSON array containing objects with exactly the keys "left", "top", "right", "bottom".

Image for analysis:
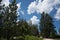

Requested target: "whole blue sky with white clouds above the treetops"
[{"left": 2, "top": 0, "right": 60, "bottom": 33}]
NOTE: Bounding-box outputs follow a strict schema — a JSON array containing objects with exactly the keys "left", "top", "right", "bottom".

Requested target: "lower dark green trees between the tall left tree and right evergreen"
[{"left": 17, "top": 20, "right": 38, "bottom": 36}]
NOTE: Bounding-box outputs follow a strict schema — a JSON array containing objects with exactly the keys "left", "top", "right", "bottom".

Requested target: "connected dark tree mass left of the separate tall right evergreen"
[{"left": 0, "top": 0, "right": 38, "bottom": 40}]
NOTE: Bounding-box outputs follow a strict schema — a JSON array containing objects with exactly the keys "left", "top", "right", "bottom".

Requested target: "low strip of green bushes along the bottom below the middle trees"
[{"left": 8, "top": 35, "right": 43, "bottom": 40}]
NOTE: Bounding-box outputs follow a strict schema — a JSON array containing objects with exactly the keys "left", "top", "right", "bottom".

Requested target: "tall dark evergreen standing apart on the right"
[{"left": 40, "top": 12, "right": 56, "bottom": 38}]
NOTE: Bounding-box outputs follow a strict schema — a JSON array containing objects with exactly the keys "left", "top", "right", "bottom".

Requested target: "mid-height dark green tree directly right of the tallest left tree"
[{"left": 18, "top": 19, "right": 29, "bottom": 36}]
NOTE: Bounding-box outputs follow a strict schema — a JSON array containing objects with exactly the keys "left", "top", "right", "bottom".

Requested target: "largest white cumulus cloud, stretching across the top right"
[{"left": 27, "top": 0, "right": 60, "bottom": 14}]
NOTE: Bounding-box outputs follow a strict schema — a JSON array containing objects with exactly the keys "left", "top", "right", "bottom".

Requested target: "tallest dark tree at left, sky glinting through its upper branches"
[{"left": 2, "top": 0, "right": 17, "bottom": 40}]
